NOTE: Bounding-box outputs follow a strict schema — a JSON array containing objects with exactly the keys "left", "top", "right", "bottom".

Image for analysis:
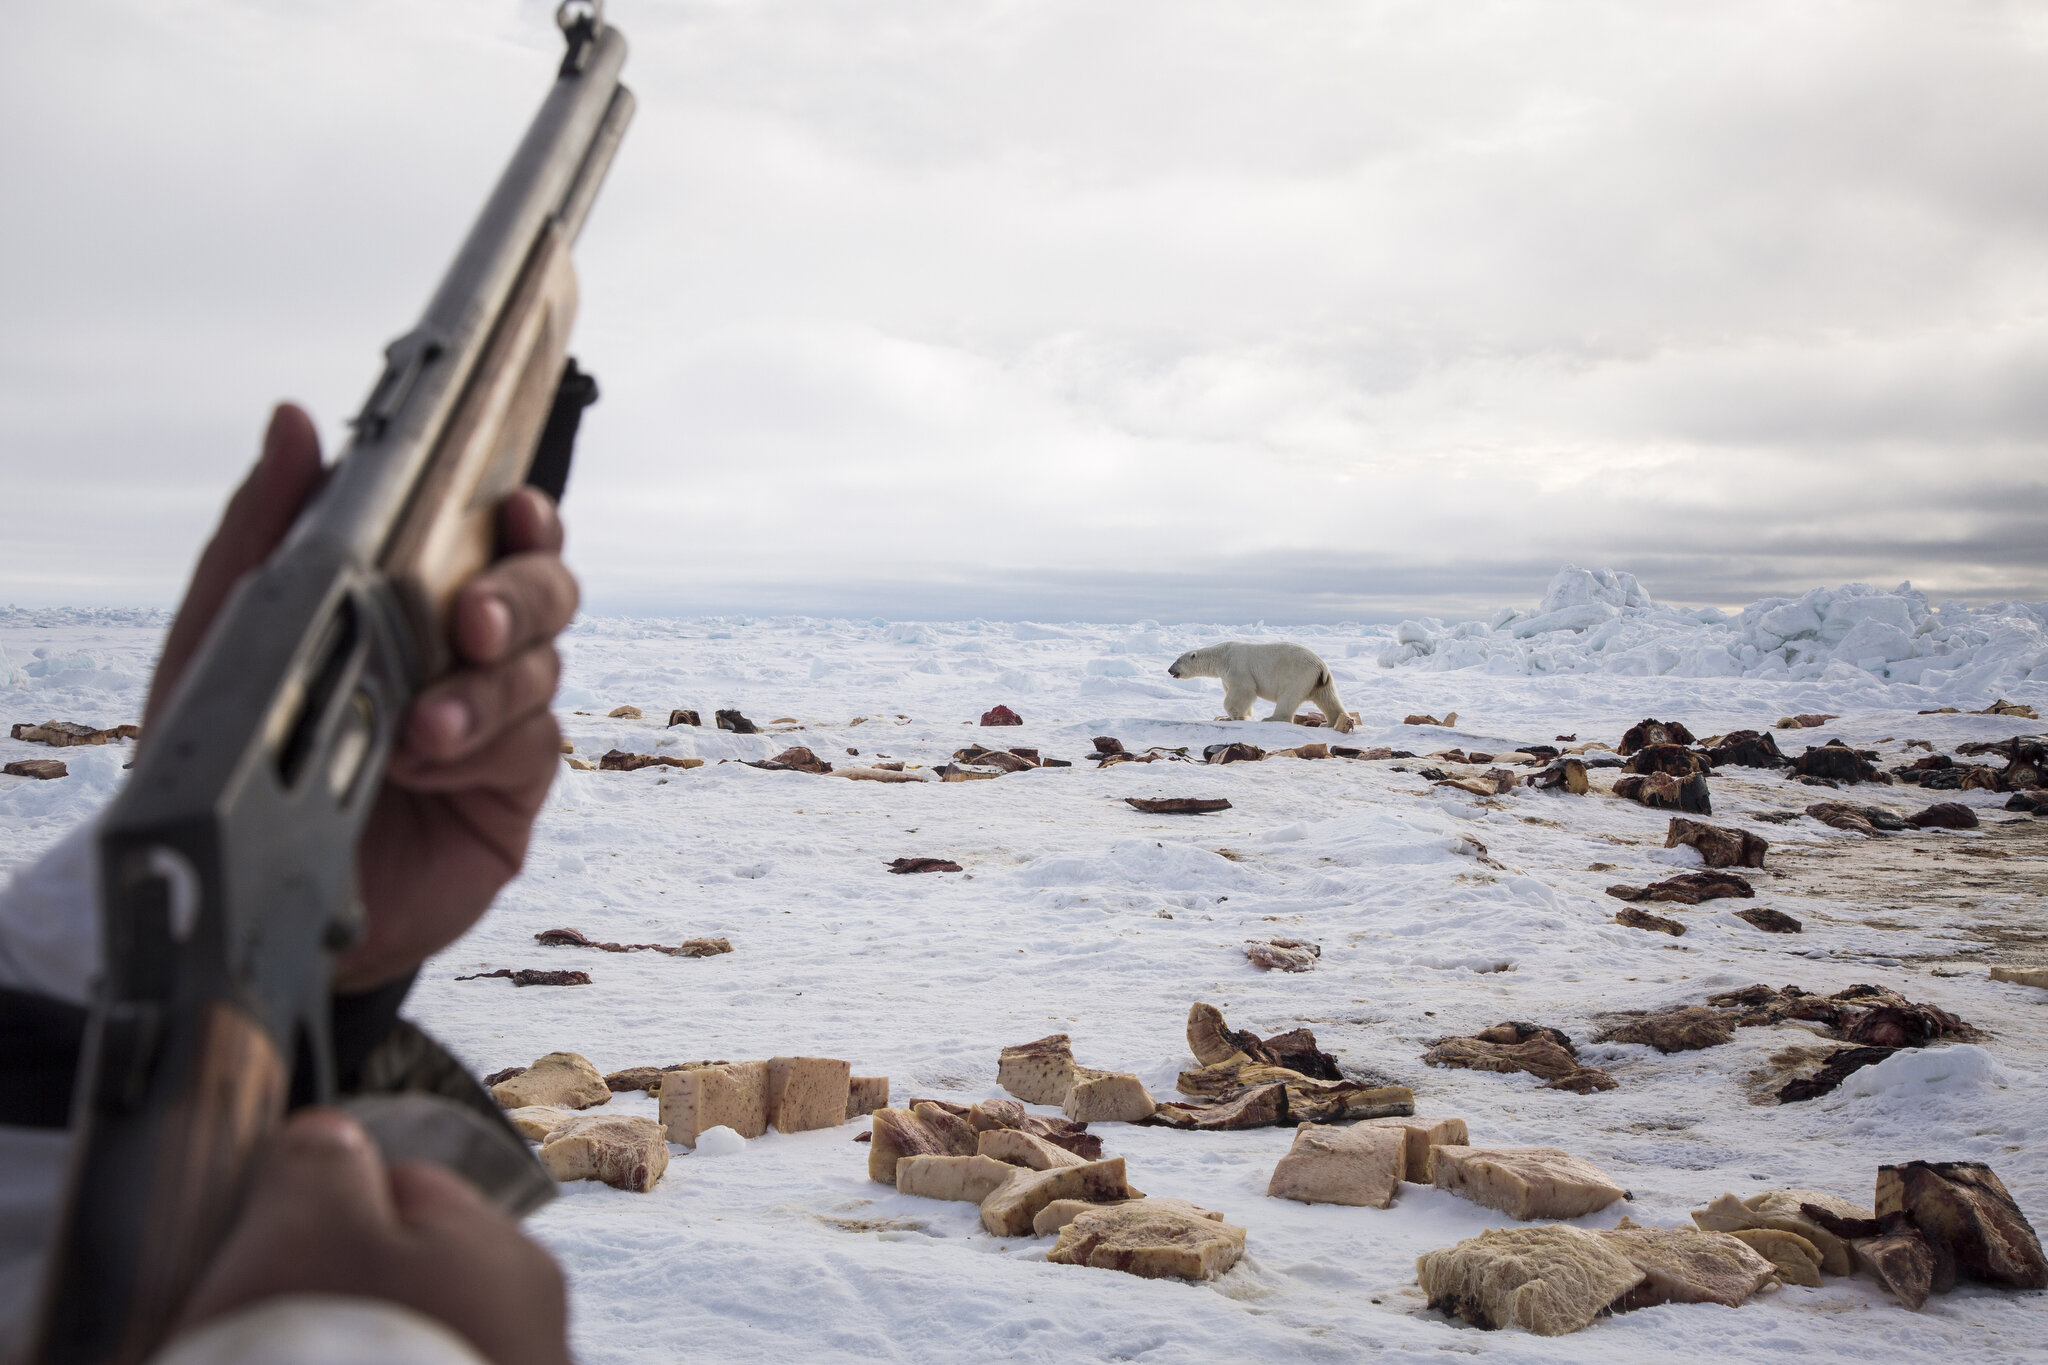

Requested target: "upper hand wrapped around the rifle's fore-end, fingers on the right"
[{"left": 143, "top": 403, "right": 578, "bottom": 995}]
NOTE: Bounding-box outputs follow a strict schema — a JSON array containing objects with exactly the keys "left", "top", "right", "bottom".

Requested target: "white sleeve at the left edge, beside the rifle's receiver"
[{"left": 0, "top": 821, "right": 100, "bottom": 1005}]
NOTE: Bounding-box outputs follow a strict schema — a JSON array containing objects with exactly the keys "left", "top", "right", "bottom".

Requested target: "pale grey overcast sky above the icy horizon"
[{"left": 0, "top": 0, "right": 2048, "bottom": 620}]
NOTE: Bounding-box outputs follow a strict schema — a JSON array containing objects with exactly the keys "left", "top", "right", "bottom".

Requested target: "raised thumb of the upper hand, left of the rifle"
[{"left": 141, "top": 403, "right": 322, "bottom": 737}]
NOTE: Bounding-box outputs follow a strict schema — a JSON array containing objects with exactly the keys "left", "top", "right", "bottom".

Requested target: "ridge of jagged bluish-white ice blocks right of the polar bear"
[{"left": 1350, "top": 565, "right": 2048, "bottom": 700}]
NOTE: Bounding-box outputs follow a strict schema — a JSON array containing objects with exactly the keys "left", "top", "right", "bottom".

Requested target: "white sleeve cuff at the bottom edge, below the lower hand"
[{"left": 147, "top": 1293, "right": 489, "bottom": 1365}]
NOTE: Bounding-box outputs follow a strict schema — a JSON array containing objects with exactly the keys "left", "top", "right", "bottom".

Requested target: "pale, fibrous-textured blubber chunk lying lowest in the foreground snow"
[{"left": 1415, "top": 1224, "right": 1645, "bottom": 1336}]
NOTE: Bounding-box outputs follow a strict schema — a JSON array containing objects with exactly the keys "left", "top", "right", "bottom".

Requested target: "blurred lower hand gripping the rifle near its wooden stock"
[{"left": 180, "top": 1109, "right": 569, "bottom": 1365}]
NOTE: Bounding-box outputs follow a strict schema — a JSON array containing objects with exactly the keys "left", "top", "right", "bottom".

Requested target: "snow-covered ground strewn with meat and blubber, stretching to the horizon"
[{"left": 0, "top": 573, "right": 2048, "bottom": 1363}]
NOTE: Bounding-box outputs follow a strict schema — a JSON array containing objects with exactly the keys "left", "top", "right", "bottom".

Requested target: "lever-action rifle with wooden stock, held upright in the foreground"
[{"left": 31, "top": 0, "right": 633, "bottom": 1365}]
